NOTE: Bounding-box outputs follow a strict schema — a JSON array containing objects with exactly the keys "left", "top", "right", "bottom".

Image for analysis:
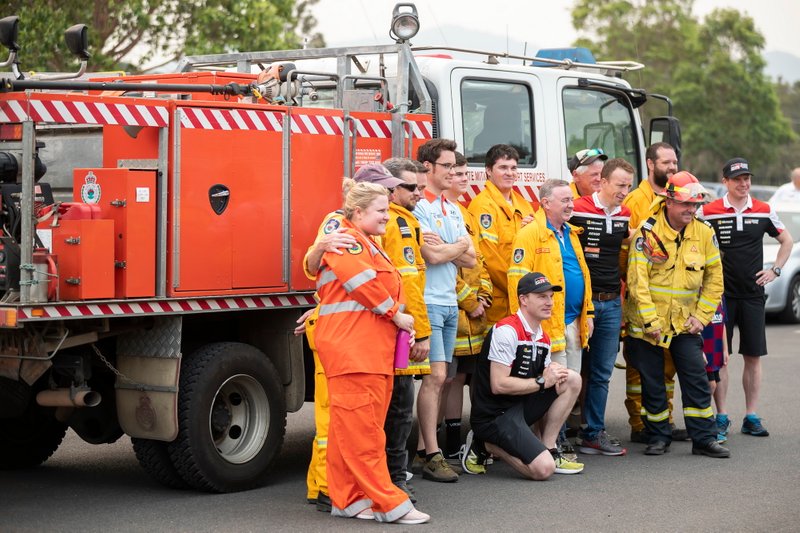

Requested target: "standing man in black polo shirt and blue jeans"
[{"left": 569, "top": 158, "right": 634, "bottom": 455}]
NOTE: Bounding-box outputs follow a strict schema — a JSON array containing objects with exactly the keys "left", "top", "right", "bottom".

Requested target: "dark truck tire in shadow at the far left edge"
[{"left": 0, "top": 402, "right": 67, "bottom": 470}]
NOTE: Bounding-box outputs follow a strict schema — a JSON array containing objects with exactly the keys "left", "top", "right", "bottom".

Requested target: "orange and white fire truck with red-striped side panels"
[{"left": 0, "top": 4, "right": 679, "bottom": 492}]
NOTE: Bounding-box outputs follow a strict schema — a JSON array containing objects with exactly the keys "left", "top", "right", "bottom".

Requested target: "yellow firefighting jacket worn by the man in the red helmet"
[{"left": 623, "top": 202, "right": 722, "bottom": 344}]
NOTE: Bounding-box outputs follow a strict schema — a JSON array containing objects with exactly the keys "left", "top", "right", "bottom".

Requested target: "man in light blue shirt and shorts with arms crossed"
[{"left": 412, "top": 139, "right": 476, "bottom": 483}]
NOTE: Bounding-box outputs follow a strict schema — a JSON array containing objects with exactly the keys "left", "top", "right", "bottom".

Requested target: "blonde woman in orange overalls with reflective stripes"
[{"left": 316, "top": 183, "right": 430, "bottom": 524}]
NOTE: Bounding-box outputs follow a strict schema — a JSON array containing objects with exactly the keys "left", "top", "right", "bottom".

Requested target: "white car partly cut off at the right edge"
[{"left": 764, "top": 203, "right": 800, "bottom": 324}]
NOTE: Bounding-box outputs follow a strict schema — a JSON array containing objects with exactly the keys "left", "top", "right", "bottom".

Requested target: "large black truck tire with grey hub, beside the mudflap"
[{"left": 169, "top": 342, "right": 286, "bottom": 492}]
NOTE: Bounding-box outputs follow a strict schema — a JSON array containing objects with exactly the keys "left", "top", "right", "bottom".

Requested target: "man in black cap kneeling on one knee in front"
[{"left": 464, "top": 272, "right": 583, "bottom": 480}]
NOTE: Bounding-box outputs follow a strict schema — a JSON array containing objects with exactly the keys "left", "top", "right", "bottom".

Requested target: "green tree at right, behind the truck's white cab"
[{"left": 572, "top": 0, "right": 794, "bottom": 179}]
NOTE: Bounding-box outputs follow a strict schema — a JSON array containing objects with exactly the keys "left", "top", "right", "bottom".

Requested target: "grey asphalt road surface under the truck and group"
[{"left": 0, "top": 324, "right": 800, "bottom": 533}]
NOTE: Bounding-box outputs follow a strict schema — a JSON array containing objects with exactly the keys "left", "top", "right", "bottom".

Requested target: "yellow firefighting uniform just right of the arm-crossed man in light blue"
[{"left": 453, "top": 204, "right": 492, "bottom": 355}]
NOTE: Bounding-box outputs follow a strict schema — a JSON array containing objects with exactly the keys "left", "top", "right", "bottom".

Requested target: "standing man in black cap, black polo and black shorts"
[{"left": 697, "top": 157, "right": 792, "bottom": 437}]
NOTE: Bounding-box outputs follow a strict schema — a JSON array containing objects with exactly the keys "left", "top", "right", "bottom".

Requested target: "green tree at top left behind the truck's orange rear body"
[{"left": 0, "top": 0, "right": 324, "bottom": 71}]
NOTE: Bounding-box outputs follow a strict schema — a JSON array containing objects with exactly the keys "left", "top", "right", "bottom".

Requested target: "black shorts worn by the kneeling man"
[{"left": 472, "top": 387, "right": 558, "bottom": 465}]
